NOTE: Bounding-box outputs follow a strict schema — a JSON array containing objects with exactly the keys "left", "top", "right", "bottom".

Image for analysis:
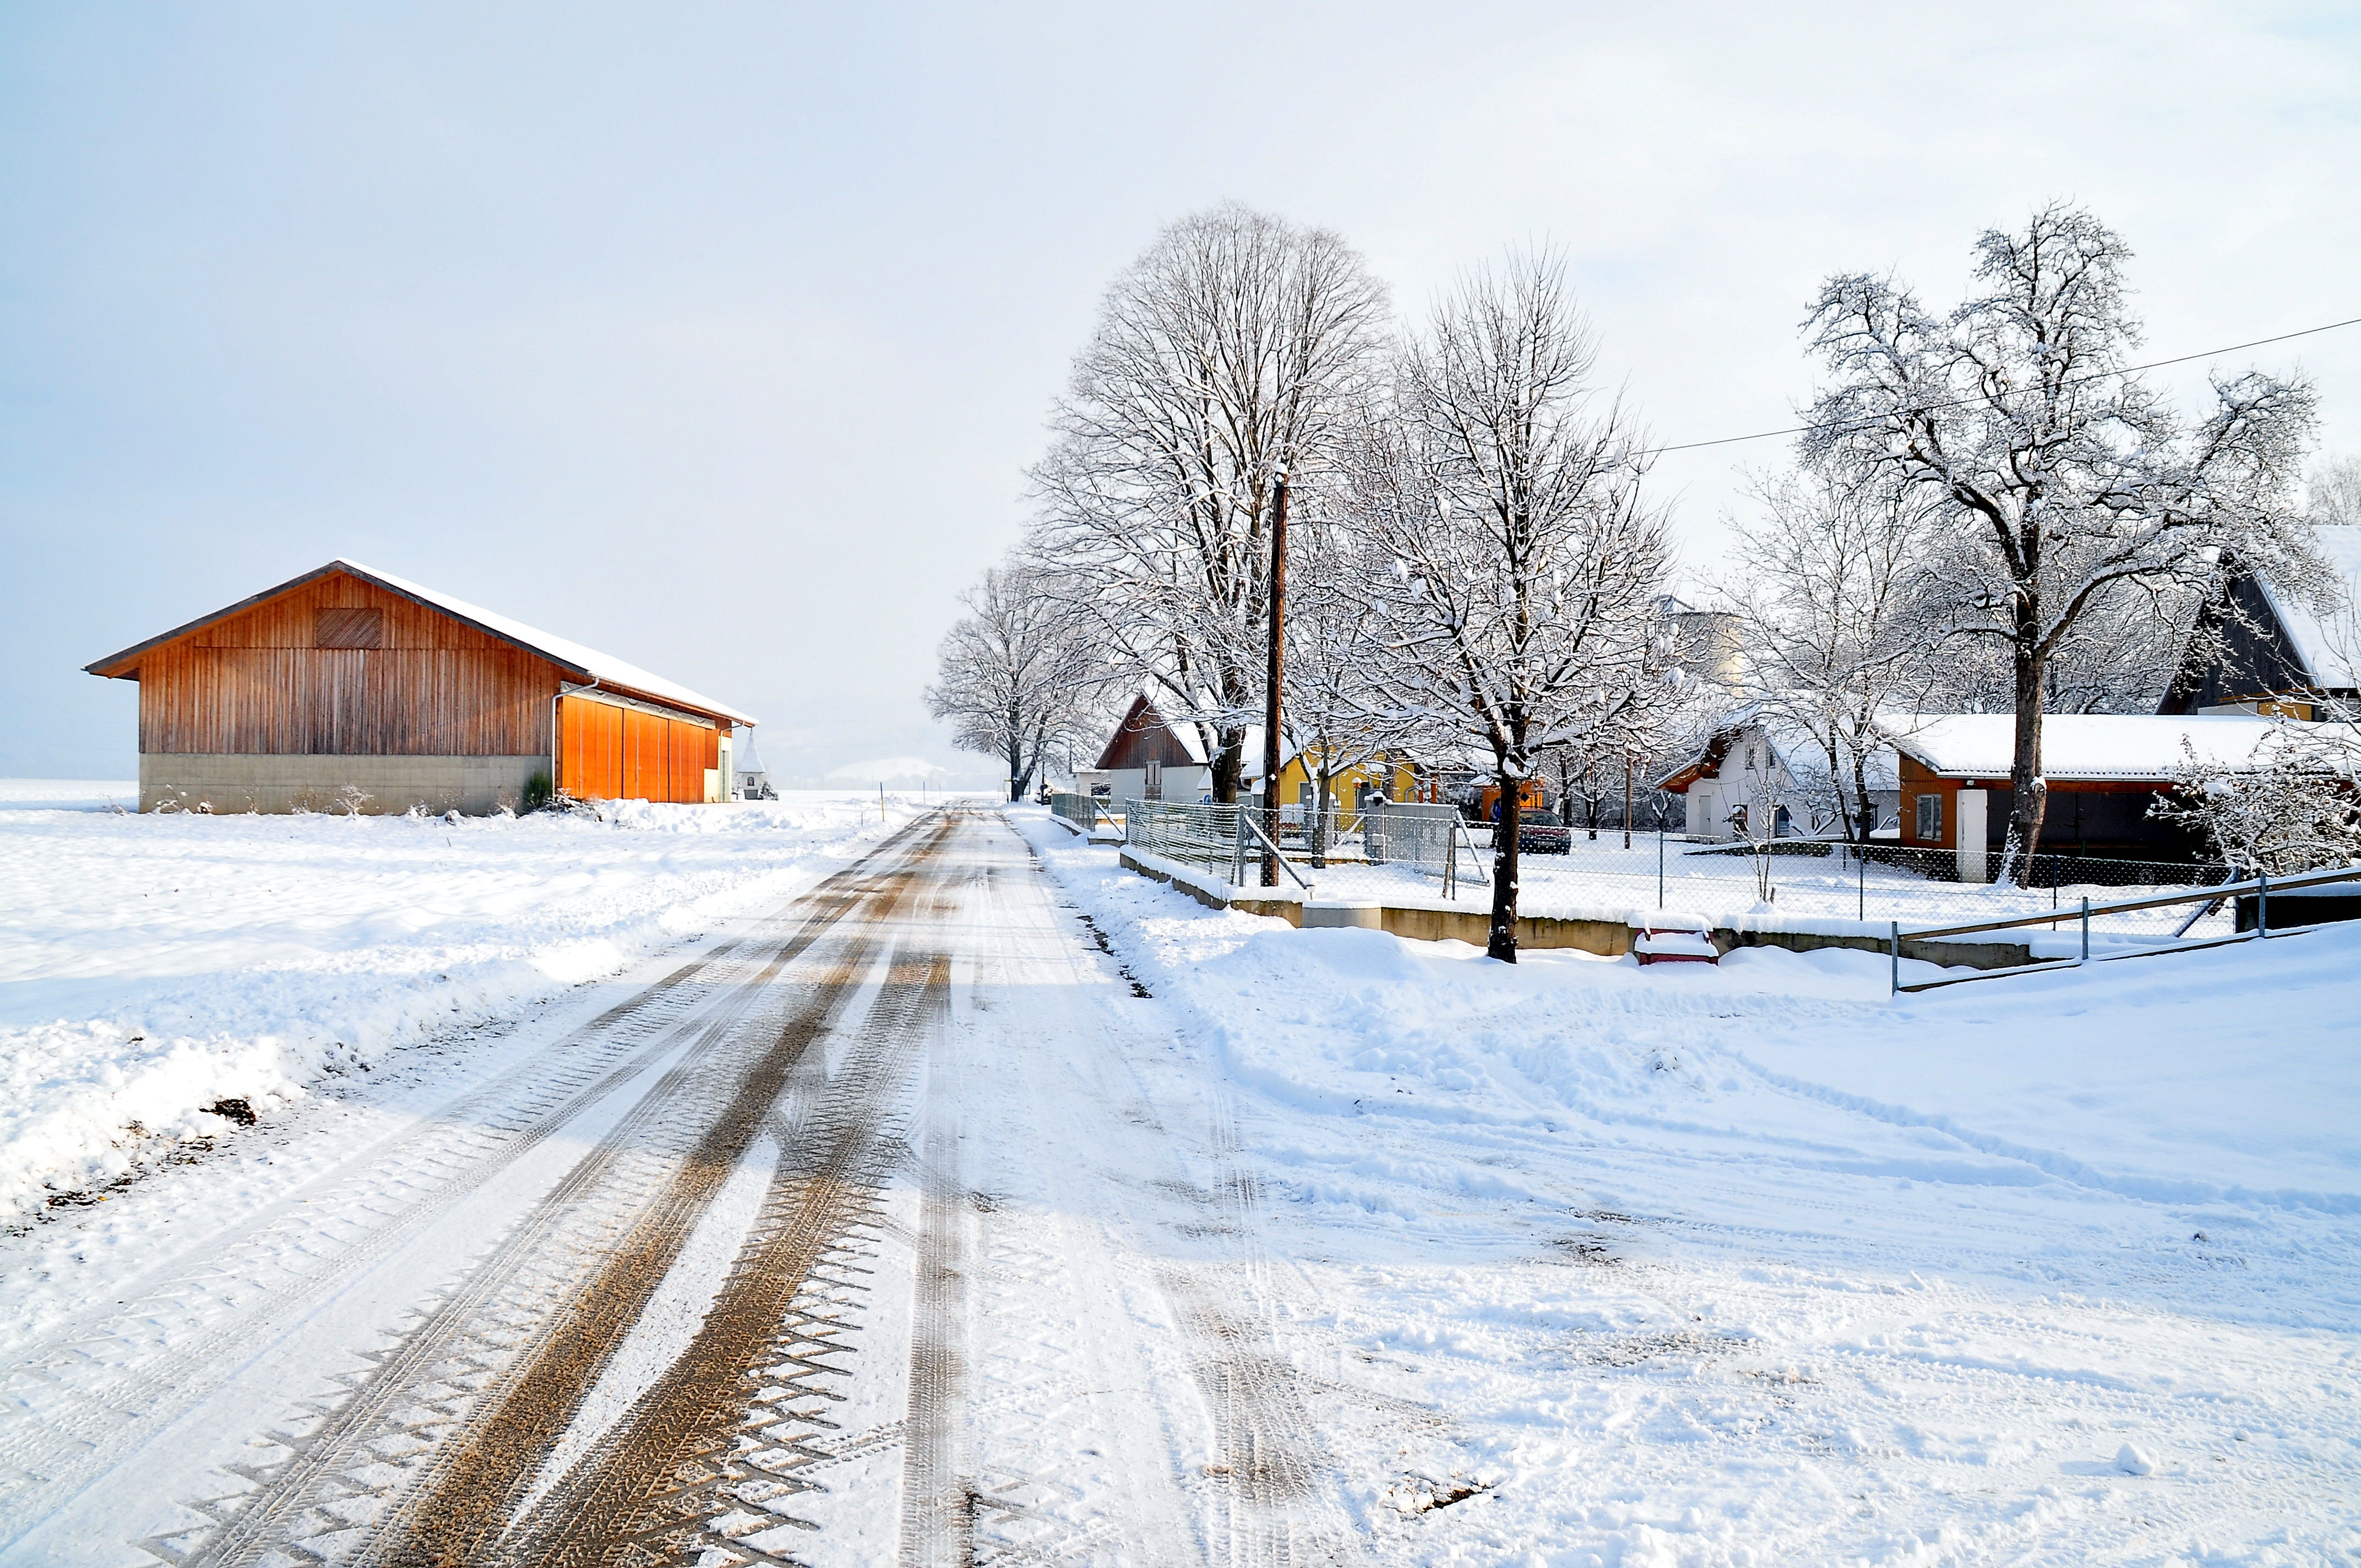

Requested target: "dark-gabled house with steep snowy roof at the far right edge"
[{"left": 2158, "top": 526, "right": 2361, "bottom": 718}]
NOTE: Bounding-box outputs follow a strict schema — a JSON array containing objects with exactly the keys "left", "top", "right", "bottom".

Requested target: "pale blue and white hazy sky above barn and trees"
[{"left": 0, "top": 2, "right": 2361, "bottom": 777}]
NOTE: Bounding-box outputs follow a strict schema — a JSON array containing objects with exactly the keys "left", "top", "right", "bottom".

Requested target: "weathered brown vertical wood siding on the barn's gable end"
[{"left": 139, "top": 576, "right": 559, "bottom": 756}]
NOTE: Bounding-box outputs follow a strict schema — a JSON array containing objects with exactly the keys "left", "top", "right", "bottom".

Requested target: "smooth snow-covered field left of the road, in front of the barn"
[{"left": 0, "top": 779, "right": 940, "bottom": 1223}]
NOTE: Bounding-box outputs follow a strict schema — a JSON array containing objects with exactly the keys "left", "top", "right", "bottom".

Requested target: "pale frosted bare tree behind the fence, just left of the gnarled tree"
[{"left": 1723, "top": 470, "right": 1932, "bottom": 843}]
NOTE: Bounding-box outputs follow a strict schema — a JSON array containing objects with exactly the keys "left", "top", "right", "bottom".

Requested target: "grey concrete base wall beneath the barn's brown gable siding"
[{"left": 139, "top": 751, "right": 550, "bottom": 817}]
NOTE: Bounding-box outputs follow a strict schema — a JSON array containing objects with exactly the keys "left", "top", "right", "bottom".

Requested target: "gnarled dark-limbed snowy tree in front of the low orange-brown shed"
[{"left": 1804, "top": 205, "right": 2319, "bottom": 881}]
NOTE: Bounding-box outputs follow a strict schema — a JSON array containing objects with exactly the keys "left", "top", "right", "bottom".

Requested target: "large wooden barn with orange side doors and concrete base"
[{"left": 85, "top": 560, "right": 753, "bottom": 815}]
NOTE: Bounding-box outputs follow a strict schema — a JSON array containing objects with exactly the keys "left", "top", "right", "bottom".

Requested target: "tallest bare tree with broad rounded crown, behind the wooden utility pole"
[{"left": 1032, "top": 205, "right": 1386, "bottom": 801}]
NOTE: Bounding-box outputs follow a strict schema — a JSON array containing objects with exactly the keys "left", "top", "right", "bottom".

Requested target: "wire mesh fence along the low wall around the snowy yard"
[{"left": 1124, "top": 801, "right": 2351, "bottom": 945}]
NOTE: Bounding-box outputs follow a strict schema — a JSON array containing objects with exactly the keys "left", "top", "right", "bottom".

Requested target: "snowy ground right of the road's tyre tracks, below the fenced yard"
[{"left": 1015, "top": 812, "right": 2361, "bottom": 1568}]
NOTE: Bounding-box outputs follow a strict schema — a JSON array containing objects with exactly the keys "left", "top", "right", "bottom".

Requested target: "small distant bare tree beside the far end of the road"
[{"left": 926, "top": 567, "right": 1105, "bottom": 801}]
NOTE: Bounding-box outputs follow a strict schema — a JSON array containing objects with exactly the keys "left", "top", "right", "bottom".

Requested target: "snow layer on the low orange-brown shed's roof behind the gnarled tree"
[{"left": 1886, "top": 713, "right": 2349, "bottom": 779}]
